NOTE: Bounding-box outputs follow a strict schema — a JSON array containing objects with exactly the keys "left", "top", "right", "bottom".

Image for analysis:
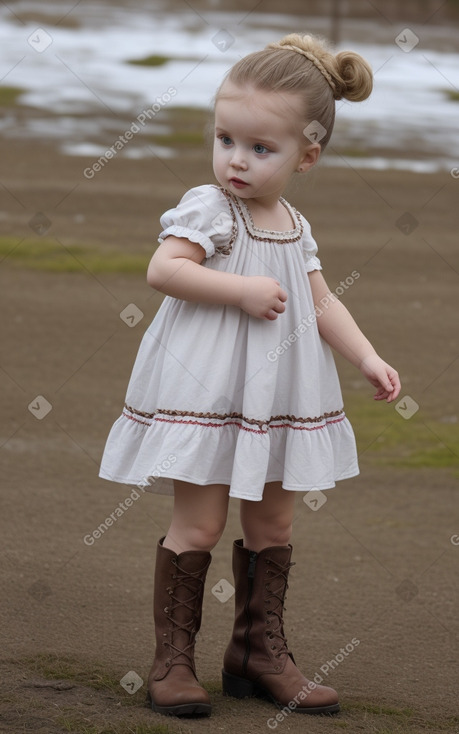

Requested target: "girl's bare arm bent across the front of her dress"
[{"left": 147, "top": 236, "right": 287, "bottom": 321}]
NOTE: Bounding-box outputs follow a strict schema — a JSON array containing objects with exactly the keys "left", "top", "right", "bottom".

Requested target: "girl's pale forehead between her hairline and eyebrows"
[{"left": 215, "top": 81, "right": 302, "bottom": 135}]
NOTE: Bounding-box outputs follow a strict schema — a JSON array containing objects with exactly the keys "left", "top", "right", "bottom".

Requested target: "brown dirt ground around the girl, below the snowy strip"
[{"left": 0, "top": 131, "right": 459, "bottom": 734}]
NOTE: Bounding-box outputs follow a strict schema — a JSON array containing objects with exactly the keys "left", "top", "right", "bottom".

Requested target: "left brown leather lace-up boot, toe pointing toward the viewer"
[{"left": 148, "top": 538, "right": 212, "bottom": 716}]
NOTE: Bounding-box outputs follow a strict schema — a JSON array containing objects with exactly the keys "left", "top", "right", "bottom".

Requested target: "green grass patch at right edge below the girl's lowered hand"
[{"left": 345, "top": 396, "right": 459, "bottom": 476}]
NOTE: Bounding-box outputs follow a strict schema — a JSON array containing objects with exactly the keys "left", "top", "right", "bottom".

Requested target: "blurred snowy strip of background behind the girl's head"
[{"left": 0, "top": 0, "right": 459, "bottom": 172}]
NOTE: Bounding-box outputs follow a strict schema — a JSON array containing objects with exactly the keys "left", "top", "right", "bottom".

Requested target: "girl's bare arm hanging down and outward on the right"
[{"left": 309, "top": 270, "right": 400, "bottom": 403}]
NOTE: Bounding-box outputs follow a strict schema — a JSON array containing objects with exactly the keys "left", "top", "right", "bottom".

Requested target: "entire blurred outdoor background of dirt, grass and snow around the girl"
[{"left": 0, "top": 5, "right": 459, "bottom": 734}]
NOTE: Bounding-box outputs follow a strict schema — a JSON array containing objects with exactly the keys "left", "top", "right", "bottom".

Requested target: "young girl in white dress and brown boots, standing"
[{"left": 100, "top": 34, "right": 400, "bottom": 715}]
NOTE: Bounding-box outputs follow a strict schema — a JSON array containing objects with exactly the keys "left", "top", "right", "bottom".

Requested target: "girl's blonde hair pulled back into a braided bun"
[{"left": 216, "top": 33, "right": 373, "bottom": 149}]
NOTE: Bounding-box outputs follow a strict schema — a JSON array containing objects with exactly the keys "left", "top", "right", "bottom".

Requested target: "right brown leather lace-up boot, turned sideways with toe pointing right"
[{"left": 223, "top": 540, "right": 339, "bottom": 714}]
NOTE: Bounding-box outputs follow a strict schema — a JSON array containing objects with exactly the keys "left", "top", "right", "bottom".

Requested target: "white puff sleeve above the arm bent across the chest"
[{"left": 158, "top": 184, "right": 235, "bottom": 258}]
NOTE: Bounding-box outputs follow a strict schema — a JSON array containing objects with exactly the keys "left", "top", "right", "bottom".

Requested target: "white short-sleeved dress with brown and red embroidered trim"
[{"left": 100, "top": 185, "right": 359, "bottom": 500}]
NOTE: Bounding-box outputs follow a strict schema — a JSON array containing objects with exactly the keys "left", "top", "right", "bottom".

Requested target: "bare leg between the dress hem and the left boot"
[{"left": 163, "top": 479, "right": 229, "bottom": 554}]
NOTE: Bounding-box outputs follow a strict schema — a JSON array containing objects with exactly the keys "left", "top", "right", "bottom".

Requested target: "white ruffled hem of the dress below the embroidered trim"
[{"left": 99, "top": 413, "right": 359, "bottom": 501}]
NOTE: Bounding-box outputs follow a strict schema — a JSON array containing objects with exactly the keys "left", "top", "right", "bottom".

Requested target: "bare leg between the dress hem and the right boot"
[{"left": 240, "top": 482, "right": 295, "bottom": 553}]
